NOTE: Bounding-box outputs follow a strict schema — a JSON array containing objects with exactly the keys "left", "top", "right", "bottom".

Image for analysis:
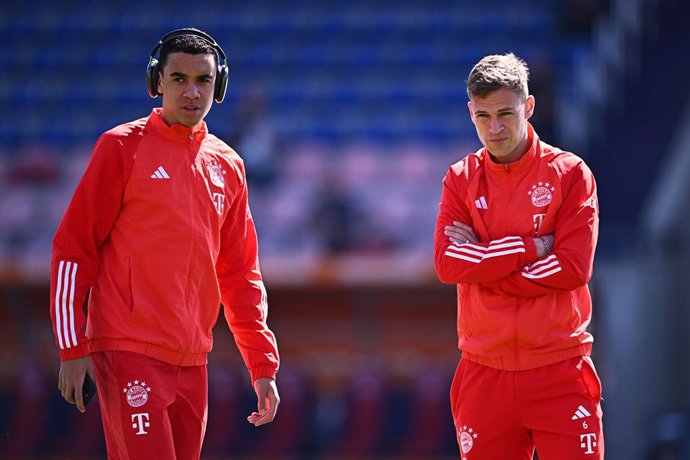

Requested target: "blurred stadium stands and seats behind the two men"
[{"left": 0, "top": 0, "right": 690, "bottom": 460}]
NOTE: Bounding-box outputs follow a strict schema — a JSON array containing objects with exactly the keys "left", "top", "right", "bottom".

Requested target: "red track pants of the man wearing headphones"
[{"left": 91, "top": 351, "right": 208, "bottom": 460}]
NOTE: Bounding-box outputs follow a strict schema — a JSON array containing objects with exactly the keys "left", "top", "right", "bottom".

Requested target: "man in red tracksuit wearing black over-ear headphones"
[{"left": 50, "top": 29, "right": 280, "bottom": 459}]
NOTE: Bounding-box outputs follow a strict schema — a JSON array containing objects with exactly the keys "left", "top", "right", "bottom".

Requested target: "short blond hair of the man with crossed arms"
[{"left": 467, "top": 53, "right": 529, "bottom": 101}]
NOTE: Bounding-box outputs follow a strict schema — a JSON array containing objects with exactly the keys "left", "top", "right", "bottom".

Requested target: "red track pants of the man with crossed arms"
[{"left": 451, "top": 357, "right": 604, "bottom": 460}]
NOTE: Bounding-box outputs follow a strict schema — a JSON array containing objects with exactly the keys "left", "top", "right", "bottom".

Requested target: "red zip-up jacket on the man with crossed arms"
[{"left": 434, "top": 125, "right": 599, "bottom": 370}]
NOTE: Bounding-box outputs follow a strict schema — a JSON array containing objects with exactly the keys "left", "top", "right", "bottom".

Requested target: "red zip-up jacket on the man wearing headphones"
[{"left": 50, "top": 109, "right": 279, "bottom": 381}]
